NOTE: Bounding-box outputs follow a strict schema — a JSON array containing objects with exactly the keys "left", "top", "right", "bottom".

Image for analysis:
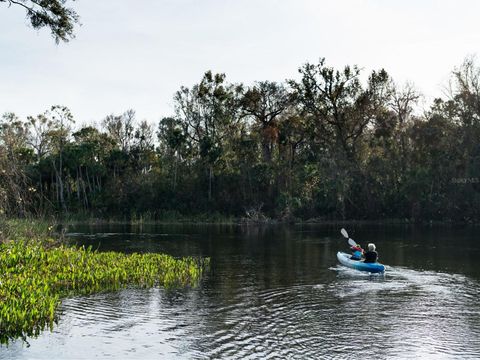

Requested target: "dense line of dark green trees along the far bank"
[{"left": 0, "top": 59, "right": 480, "bottom": 221}]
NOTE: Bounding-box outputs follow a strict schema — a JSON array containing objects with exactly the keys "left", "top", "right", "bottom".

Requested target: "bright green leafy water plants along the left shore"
[{"left": 0, "top": 220, "right": 210, "bottom": 344}]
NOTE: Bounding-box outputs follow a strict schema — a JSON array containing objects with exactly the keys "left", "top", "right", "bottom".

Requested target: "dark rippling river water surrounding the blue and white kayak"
[{"left": 0, "top": 226, "right": 480, "bottom": 359}]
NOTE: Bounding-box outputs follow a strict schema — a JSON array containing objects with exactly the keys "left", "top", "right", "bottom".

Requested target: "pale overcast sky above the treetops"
[{"left": 0, "top": 0, "right": 480, "bottom": 124}]
